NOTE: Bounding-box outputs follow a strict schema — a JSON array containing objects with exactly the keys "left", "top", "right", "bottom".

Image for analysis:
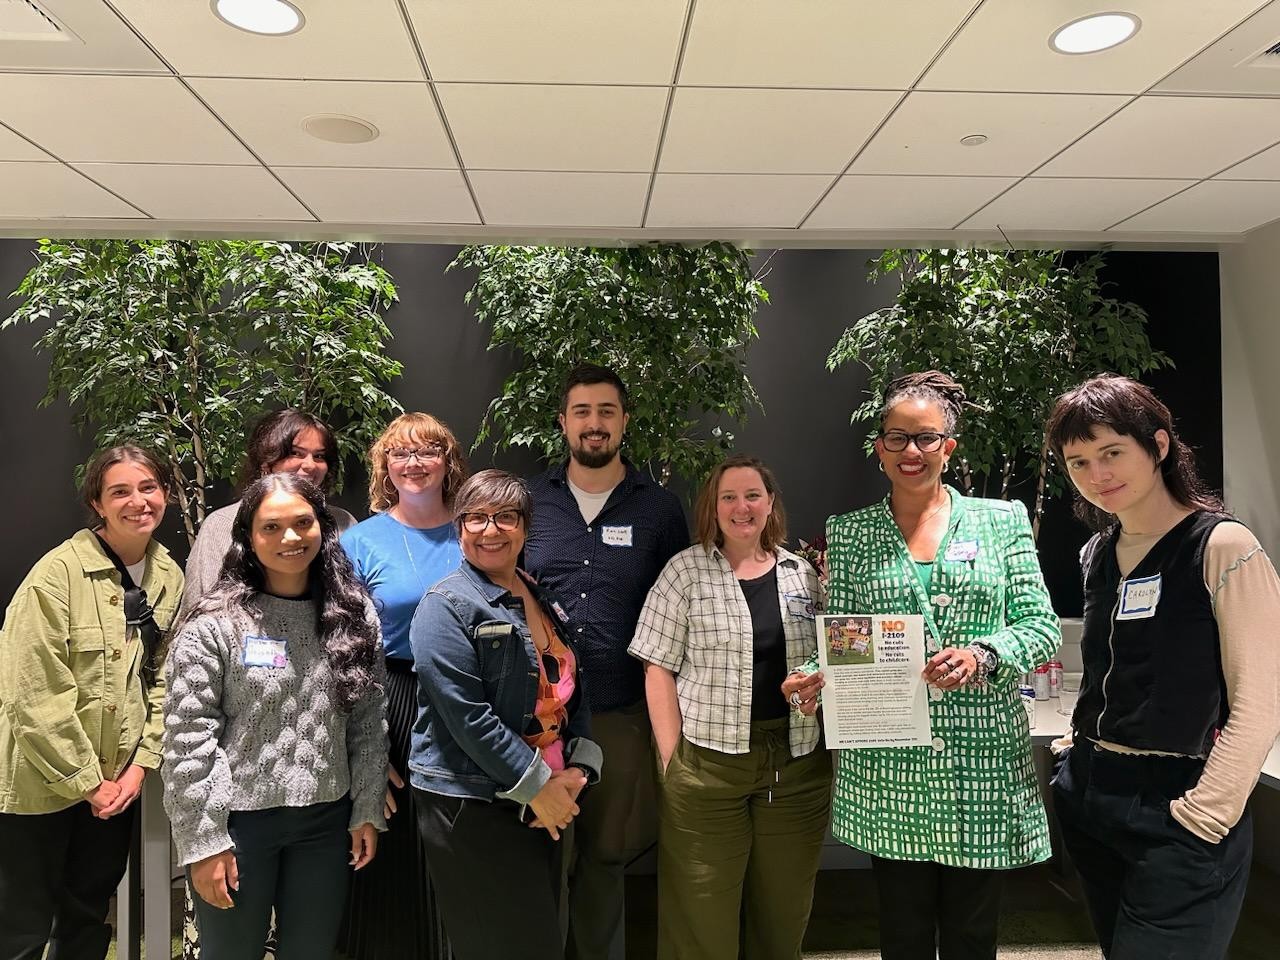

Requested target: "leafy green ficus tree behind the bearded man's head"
[{"left": 451, "top": 243, "right": 768, "bottom": 483}]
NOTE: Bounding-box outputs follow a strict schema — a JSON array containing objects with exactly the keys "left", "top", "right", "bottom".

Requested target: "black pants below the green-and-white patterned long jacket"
[{"left": 872, "top": 856, "right": 1007, "bottom": 960}]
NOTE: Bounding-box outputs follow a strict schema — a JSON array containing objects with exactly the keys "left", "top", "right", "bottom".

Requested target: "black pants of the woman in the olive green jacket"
[{"left": 0, "top": 803, "right": 137, "bottom": 960}]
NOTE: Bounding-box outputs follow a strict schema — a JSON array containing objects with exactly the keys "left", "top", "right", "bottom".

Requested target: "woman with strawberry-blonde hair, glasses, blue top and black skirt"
[{"left": 339, "top": 413, "right": 467, "bottom": 960}]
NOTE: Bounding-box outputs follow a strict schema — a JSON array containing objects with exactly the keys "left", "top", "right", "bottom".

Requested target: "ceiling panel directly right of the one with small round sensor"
[{"left": 1038, "top": 96, "right": 1280, "bottom": 178}]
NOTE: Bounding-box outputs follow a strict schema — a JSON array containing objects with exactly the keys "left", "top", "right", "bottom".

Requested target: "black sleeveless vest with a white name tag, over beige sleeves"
[{"left": 1071, "top": 511, "right": 1231, "bottom": 756}]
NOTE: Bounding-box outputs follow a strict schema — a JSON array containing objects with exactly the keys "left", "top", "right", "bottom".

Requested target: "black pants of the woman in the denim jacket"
[{"left": 413, "top": 787, "right": 564, "bottom": 960}]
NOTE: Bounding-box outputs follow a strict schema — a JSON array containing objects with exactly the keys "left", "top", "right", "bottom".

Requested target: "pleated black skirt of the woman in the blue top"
[{"left": 338, "top": 659, "right": 452, "bottom": 960}]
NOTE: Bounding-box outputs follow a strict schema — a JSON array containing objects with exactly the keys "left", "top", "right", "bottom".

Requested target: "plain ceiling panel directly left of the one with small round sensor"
[{"left": 659, "top": 87, "right": 901, "bottom": 174}]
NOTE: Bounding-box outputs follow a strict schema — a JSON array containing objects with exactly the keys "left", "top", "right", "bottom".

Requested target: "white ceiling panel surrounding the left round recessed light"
[{"left": 113, "top": 0, "right": 425, "bottom": 81}]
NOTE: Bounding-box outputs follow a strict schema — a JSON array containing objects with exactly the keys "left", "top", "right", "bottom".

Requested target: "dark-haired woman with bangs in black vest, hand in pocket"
[{"left": 1047, "top": 375, "right": 1280, "bottom": 960}]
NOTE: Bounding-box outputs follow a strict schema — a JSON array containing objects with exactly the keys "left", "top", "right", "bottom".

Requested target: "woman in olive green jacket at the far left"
[{"left": 0, "top": 447, "right": 182, "bottom": 960}]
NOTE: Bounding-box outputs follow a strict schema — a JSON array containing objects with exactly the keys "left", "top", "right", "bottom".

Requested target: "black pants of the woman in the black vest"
[{"left": 1053, "top": 742, "right": 1253, "bottom": 960}]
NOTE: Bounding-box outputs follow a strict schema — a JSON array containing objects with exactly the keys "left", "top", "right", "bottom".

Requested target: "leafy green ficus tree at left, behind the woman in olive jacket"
[{"left": 3, "top": 239, "right": 401, "bottom": 541}]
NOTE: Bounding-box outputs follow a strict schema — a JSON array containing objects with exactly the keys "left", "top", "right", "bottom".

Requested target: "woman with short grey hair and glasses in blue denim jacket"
[{"left": 408, "top": 470, "right": 602, "bottom": 960}]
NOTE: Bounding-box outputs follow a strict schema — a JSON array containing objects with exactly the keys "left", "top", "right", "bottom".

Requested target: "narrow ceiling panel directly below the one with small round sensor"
[{"left": 804, "top": 177, "right": 1016, "bottom": 230}]
